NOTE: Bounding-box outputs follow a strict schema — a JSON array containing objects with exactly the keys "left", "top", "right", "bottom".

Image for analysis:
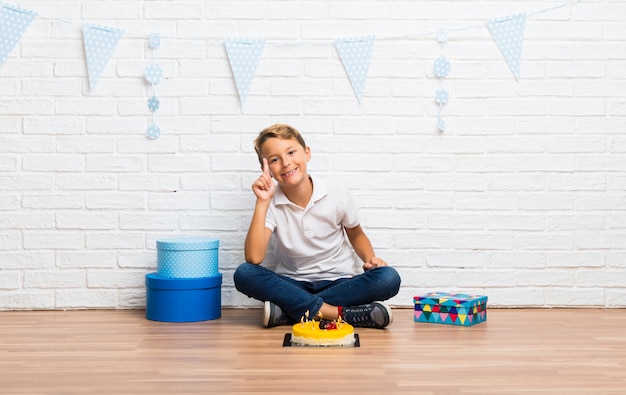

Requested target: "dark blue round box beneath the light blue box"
[{"left": 146, "top": 273, "right": 222, "bottom": 322}]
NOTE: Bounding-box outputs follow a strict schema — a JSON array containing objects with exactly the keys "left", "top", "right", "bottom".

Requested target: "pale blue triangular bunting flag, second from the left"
[{"left": 83, "top": 23, "right": 124, "bottom": 91}]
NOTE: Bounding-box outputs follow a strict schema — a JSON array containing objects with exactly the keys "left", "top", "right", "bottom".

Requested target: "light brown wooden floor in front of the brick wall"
[{"left": 0, "top": 309, "right": 626, "bottom": 395}]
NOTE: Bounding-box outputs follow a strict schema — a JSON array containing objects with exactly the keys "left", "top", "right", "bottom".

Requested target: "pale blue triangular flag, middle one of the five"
[{"left": 224, "top": 38, "right": 265, "bottom": 105}]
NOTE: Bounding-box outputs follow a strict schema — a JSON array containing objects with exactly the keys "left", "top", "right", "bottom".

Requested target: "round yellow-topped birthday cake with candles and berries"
[{"left": 291, "top": 319, "right": 355, "bottom": 347}]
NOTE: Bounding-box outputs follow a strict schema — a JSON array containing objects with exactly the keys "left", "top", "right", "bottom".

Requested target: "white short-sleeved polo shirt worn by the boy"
[{"left": 265, "top": 177, "right": 361, "bottom": 281}]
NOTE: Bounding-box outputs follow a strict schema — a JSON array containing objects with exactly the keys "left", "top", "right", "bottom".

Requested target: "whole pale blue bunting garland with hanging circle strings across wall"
[{"left": 0, "top": 0, "right": 581, "bottom": 125}]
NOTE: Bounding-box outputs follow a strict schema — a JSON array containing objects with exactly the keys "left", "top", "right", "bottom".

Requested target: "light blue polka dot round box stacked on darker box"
[{"left": 156, "top": 237, "right": 220, "bottom": 278}]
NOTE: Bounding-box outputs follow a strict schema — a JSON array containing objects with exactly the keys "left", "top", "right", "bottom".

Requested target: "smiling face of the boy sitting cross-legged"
[{"left": 261, "top": 137, "right": 311, "bottom": 186}]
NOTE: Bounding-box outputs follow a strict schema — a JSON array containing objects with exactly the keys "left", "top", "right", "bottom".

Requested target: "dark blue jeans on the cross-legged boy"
[{"left": 233, "top": 263, "right": 400, "bottom": 321}]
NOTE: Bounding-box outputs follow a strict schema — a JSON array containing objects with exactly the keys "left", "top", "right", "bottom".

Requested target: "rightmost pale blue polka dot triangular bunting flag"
[{"left": 487, "top": 14, "right": 526, "bottom": 80}]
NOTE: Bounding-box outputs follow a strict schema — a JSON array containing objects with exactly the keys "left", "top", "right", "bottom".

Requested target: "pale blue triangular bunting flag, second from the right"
[{"left": 335, "top": 36, "right": 375, "bottom": 103}]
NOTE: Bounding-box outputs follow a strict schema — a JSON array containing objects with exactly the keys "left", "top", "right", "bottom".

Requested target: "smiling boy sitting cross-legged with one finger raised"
[{"left": 234, "top": 124, "right": 400, "bottom": 328}]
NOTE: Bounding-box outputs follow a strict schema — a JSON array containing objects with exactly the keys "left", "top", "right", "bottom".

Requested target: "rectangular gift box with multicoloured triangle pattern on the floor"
[{"left": 413, "top": 292, "right": 487, "bottom": 326}]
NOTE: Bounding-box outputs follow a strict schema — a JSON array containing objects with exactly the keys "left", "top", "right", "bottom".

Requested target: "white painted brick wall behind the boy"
[{"left": 0, "top": 0, "right": 626, "bottom": 310}]
